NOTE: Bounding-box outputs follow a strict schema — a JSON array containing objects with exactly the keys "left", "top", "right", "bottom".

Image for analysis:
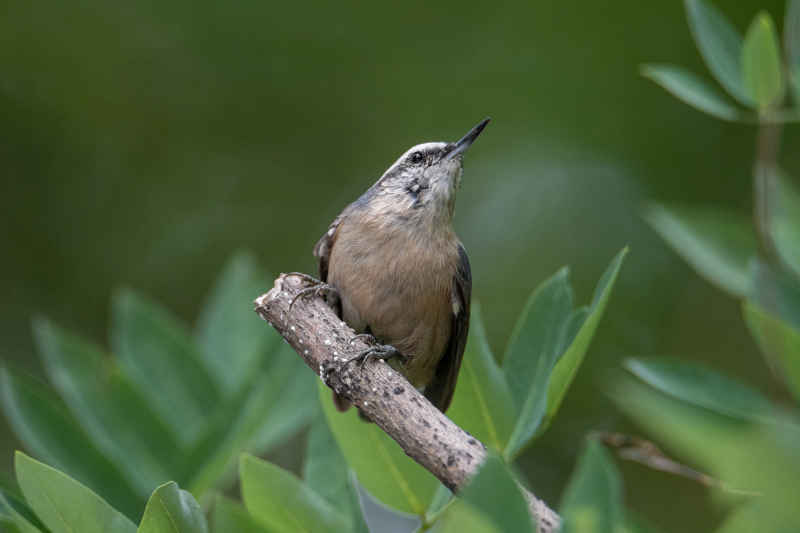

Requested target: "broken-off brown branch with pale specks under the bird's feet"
[{"left": 255, "top": 274, "right": 561, "bottom": 533}]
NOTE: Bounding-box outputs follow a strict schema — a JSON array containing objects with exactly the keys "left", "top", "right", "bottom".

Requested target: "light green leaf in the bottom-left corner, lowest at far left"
[{"left": 14, "top": 452, "right": 136, "bottom": 533}]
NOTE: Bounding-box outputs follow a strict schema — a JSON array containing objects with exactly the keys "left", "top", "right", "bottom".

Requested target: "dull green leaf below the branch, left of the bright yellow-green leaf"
[{"left": 303, "top": 413, "right": 368, "bottom": 533}]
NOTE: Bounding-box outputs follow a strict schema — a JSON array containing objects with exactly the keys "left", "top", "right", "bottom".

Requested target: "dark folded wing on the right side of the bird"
[{"left": 425, "top": 244, "right": 472, "bottom": 412}]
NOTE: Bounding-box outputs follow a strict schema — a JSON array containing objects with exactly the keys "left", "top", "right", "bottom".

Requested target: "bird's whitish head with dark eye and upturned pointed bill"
[{"left": 373, "top": 118, "right": 489, "bottom": 223}]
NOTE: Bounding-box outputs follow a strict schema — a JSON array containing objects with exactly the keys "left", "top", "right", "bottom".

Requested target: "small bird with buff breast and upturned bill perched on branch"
[{"left": 313, "top": 118, "right": 490, "bottom": 417}]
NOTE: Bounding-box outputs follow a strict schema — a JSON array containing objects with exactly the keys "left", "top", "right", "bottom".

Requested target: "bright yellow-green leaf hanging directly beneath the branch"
[{"left": 318, "top": 383, "right": 439, "bottom": 516}]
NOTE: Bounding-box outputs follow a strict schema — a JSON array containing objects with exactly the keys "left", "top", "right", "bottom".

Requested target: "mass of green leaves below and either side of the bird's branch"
[{"left": 0, "top": 244, "right": 626, "bottom": 533}]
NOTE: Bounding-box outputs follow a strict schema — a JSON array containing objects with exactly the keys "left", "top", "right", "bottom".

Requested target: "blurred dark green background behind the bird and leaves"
[{"left": 0, "top": 0, "right": 800, "bottom": 532}]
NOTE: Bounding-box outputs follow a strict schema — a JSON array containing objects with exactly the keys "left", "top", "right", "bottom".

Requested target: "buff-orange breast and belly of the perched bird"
[{"left": 328, "top": 216, "right": 458, "bottom": 387}]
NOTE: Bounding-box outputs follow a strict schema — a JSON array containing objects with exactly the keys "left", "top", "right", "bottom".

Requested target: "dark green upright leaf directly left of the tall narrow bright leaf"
[{"left": 503, "top": 268, "right": 573, "bottom": 457}]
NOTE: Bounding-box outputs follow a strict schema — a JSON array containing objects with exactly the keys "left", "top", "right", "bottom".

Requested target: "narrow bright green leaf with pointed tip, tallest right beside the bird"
[{"left": 539, "top": 248, "right": 628, "bottom": 433}]
